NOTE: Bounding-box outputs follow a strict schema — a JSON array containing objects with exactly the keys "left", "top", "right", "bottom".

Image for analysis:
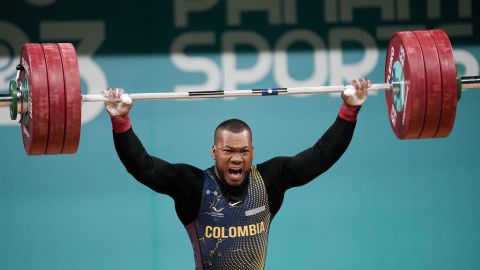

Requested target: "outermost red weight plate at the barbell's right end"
[{"left": 429, "top": 30, "right": 457, "bottom": 138}]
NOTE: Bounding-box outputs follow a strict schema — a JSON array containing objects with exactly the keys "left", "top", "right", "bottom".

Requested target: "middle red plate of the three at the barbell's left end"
[{"left": 42, "top": 44, "right": 65, "bottom": 155}]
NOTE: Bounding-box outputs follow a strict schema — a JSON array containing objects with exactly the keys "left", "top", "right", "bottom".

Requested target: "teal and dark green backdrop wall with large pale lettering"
[{"left": 0, "top": 0, "right": 480, "bottom": 270}]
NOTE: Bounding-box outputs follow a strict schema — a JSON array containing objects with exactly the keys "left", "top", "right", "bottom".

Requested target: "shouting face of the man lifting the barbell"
[{"left": 212, "top": 129, "right": 253, "bottom": 186}]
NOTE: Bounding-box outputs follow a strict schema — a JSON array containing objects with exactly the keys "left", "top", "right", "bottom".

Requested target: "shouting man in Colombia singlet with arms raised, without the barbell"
[{"left": 103, "top": 78, "right": 371, "bottom": 269}]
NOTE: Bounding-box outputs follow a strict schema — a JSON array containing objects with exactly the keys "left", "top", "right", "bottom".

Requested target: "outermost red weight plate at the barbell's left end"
[{"left": 19, "top": 43, "right": 49, "bottom": 155}]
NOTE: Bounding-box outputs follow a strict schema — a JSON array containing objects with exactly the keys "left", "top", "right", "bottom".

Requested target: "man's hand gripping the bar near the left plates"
[{"left": 102, "top": 88, "right": 133, "bottom": 117}]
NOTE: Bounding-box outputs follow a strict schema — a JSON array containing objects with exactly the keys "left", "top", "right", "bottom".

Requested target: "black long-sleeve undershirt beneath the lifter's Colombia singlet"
[{"left": 113, "top": 117, "right": 355, "bottom": 226}]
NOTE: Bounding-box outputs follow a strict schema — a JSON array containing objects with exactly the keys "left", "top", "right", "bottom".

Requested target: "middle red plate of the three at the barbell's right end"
[{"left": 414, "top": 31, "right": 442, "bottom": 139}]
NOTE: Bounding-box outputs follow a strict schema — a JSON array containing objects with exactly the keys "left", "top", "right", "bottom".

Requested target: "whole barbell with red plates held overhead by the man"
[{"left": 0, "top": 29, "right": 480, "bottom": 155}]
